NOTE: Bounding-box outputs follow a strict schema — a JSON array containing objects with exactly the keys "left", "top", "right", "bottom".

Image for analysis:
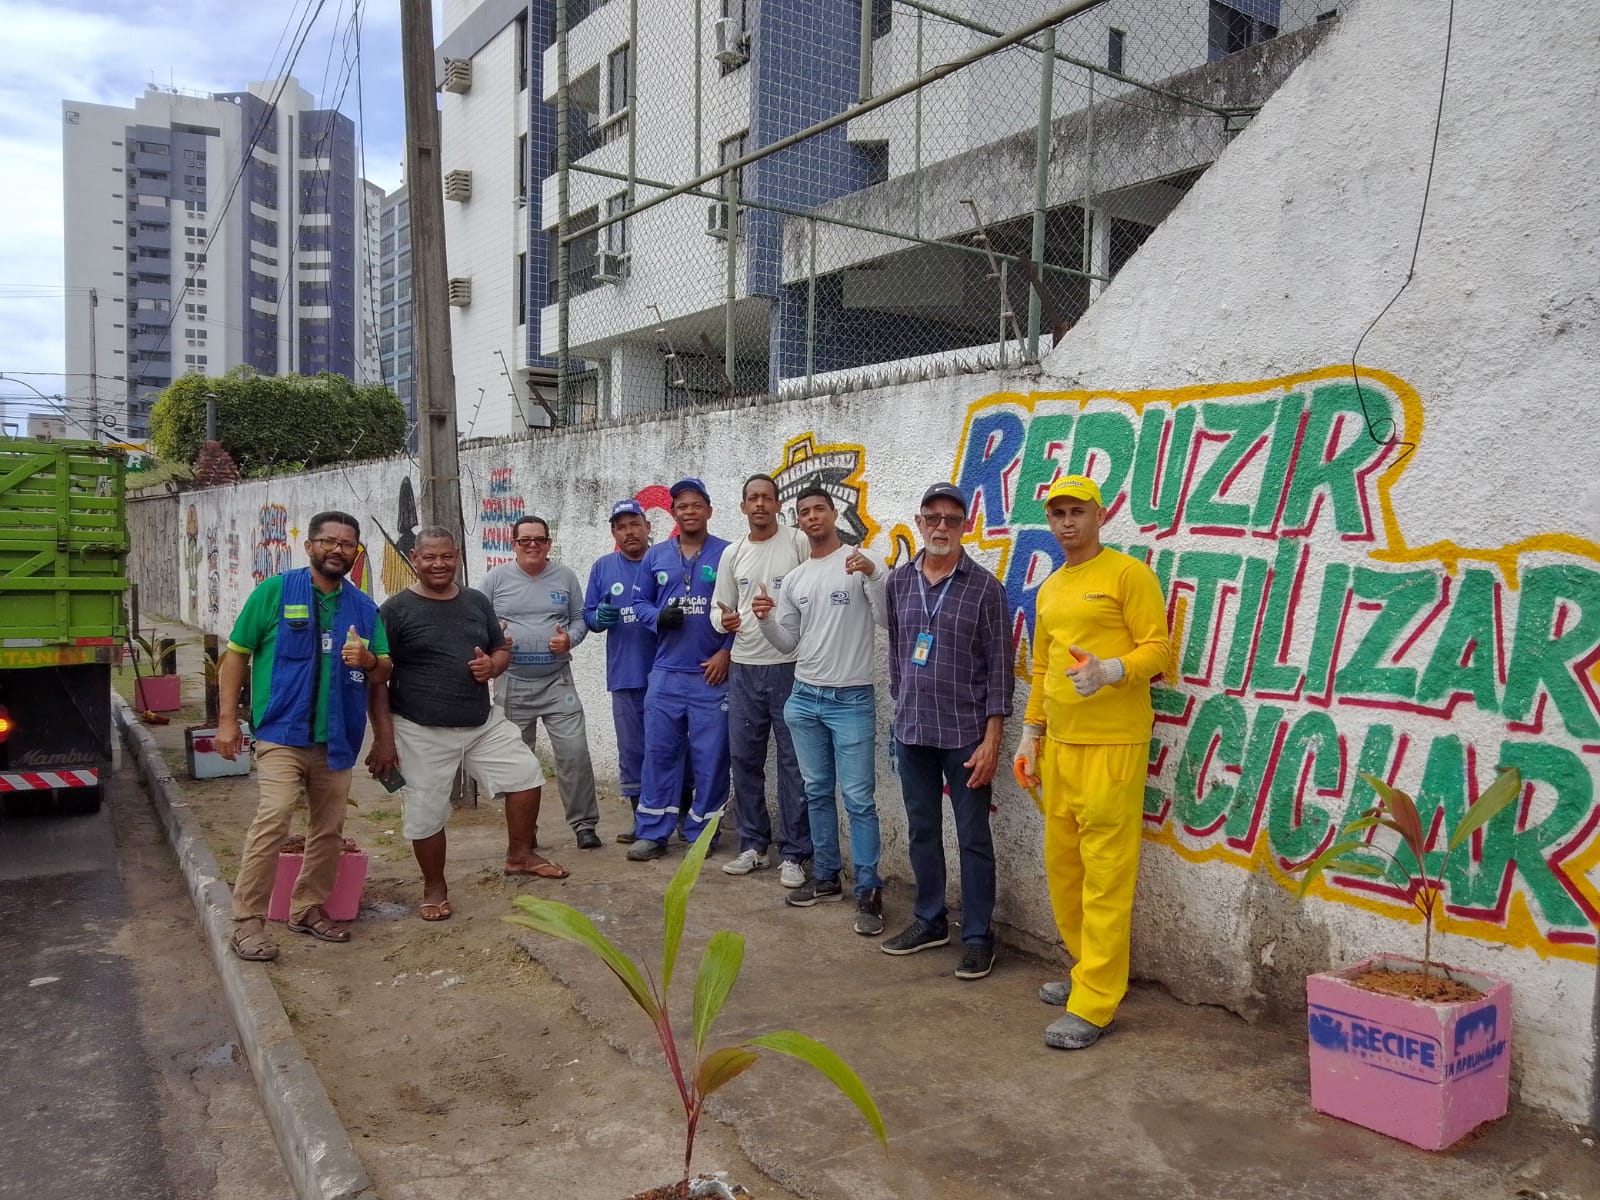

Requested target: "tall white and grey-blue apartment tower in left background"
[{"left": 62, "top": 78, "right": 378, "bottom": 440}]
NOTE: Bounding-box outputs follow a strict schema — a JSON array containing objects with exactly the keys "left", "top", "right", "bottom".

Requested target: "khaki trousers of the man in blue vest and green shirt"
[{"left": 234, "top": 741, "right": 352, "bottom": 922}]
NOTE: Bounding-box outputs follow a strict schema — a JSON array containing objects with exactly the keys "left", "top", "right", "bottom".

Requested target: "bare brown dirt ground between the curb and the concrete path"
[{"left": 176, "top": 742, "right": 792, "bottom": 1200}]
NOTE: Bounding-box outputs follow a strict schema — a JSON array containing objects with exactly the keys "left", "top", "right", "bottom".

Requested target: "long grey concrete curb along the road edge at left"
[{"left": 112, "top": 696, "right": 378, "bottom": 1200}]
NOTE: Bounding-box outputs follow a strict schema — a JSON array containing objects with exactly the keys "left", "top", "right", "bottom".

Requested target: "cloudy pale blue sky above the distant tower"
[{"left": 0, "top": 0, "right": 442, "bottom": 432}]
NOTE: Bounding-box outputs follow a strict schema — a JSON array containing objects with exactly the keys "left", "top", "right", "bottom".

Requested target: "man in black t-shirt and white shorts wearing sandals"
[{"left": 366, "top": 528, "right": 566, "bottom": 922}]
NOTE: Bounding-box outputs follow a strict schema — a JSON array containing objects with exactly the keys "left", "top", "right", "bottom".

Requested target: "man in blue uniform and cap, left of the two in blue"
[{"left": 584, "top": 499, "right": 656, "bottom": 845}]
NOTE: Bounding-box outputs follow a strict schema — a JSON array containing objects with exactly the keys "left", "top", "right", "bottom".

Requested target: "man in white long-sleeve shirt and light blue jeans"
[{"left": 750, "top": 488, "right": 888, "bottom": 936}]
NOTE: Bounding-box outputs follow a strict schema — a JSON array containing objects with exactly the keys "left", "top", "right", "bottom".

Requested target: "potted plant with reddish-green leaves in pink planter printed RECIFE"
[{"left": 1299, "top": 768, "right": 1522, "bottom": 1150}]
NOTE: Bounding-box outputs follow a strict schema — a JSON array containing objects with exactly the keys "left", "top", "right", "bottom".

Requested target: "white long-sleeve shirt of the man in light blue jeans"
[{"left": 760, "top": 546, "right": 890, "bottom": 688}]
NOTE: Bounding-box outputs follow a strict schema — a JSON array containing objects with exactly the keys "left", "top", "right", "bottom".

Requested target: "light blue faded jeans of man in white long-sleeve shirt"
[{"left": 784, "top": 680, "right": 883, "bottom": 896}]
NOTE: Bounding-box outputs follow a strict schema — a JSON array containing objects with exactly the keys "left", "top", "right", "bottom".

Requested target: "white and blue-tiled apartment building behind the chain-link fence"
[{"left": 438, "top": 0, "right": 1336, "bottom": 435}]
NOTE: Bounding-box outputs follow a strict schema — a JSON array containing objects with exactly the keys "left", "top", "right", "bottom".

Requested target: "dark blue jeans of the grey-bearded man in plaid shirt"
[{"left": 894, "top": 741, "right": 995, "bottom": 946}]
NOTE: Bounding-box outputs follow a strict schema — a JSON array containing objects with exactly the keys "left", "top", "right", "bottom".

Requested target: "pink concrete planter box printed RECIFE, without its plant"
[{"left": 1306, "top": 955, "right": 1510, "bottom": 1150}]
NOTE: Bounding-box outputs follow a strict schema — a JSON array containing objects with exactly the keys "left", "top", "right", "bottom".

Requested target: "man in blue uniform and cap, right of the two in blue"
[{"left": 627, "top": 478, "right": 733, "bottom": 862}]
